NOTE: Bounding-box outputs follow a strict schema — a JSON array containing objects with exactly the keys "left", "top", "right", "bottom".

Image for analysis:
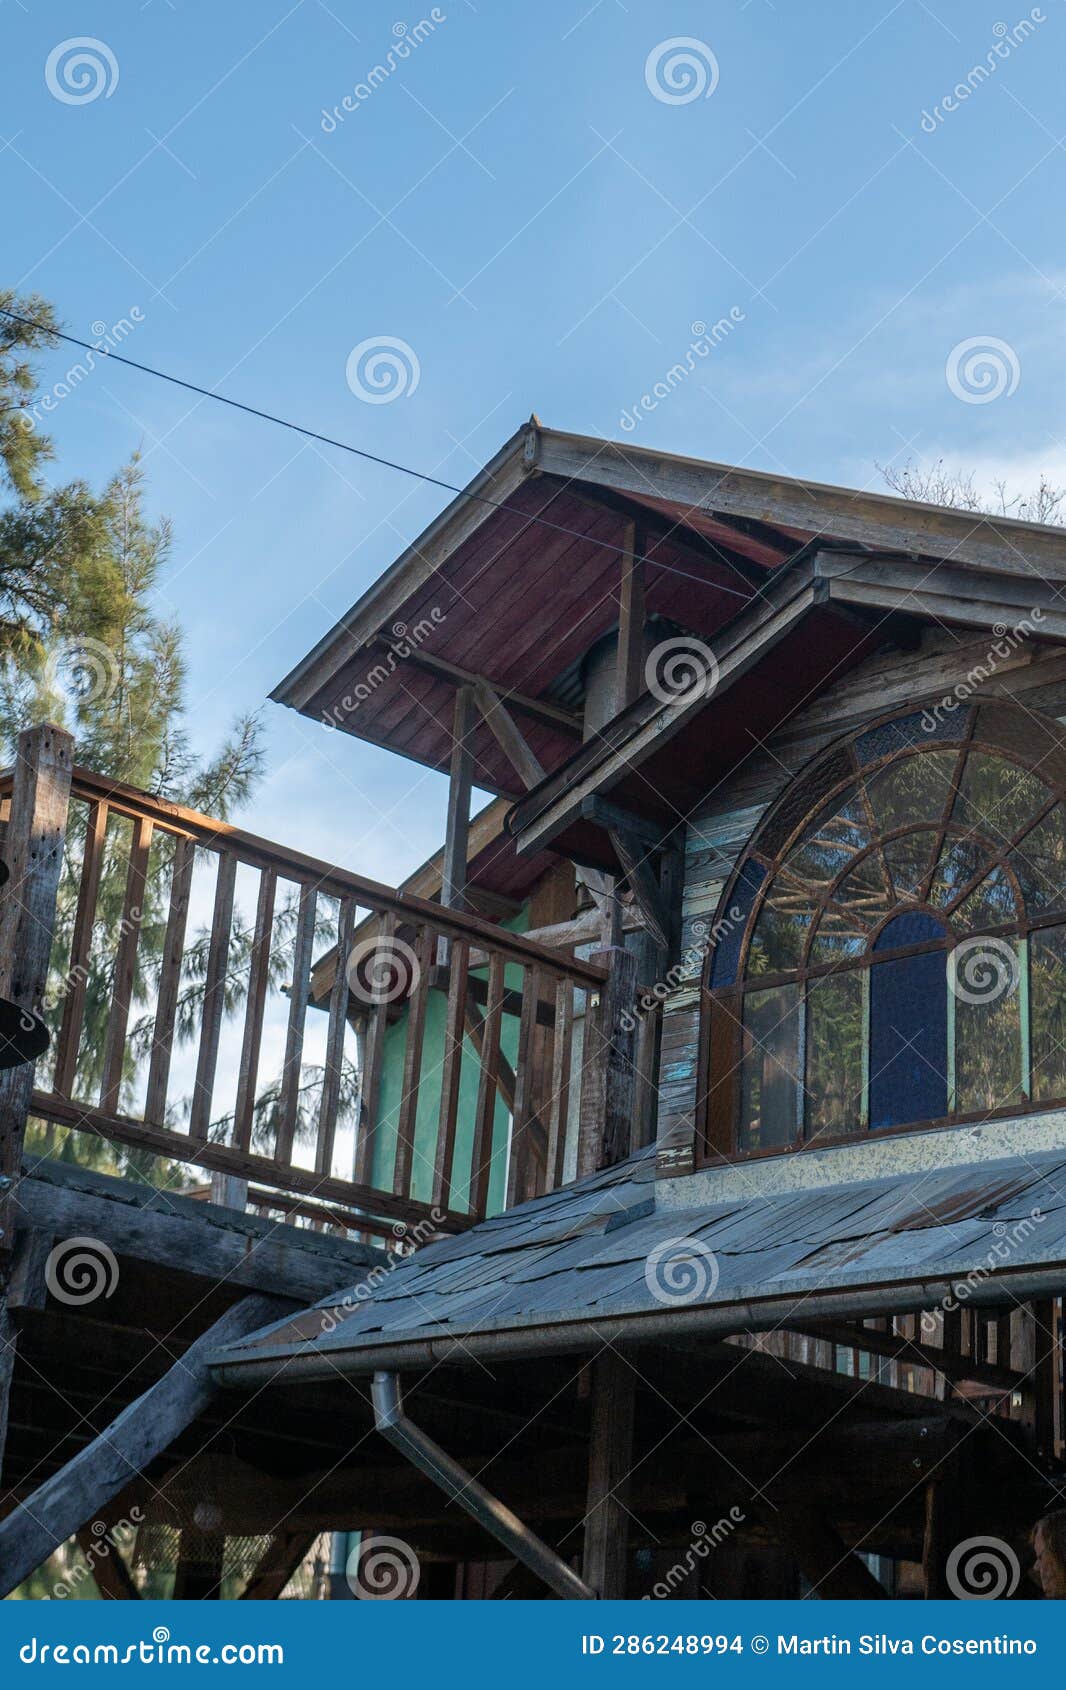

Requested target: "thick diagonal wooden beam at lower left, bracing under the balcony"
[{"left": 0, "top": 1296, "right": 283, "bottom": 1595}]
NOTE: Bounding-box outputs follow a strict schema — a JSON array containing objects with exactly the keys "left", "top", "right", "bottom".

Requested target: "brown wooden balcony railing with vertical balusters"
[{"left": 0, "top": 740, "right": 608, "bottom": 1232}]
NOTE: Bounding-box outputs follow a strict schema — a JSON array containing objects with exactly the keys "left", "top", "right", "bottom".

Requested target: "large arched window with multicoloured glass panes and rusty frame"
[{"left": 703, "top": 700, "right": 1066, "bottom": 1151}]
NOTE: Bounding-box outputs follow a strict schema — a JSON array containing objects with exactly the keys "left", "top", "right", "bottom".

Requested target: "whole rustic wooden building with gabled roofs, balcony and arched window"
[{"left": 0, "top": 419, "right": 1066, "bottom": 1597}]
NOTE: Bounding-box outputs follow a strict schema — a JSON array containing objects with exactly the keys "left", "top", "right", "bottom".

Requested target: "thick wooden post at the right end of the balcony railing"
[{"left": 578, "top": 946, "right": 637, "bottom": 1178}]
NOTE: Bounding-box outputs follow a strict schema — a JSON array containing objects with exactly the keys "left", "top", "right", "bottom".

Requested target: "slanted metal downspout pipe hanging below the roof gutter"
[{"left": 372, "top": 1372, "right": 596, "bottom": 1602}]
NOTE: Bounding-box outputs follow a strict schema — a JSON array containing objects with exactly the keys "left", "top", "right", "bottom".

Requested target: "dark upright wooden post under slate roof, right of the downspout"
[{"left": 583, "top": 1350, "right": 635, "bottom": 1600}]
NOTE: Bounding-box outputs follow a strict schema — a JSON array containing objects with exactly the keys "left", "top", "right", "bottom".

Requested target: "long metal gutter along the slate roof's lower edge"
[{"left": 208, "top": 1262, "right": 1066, "bottom": 1389}]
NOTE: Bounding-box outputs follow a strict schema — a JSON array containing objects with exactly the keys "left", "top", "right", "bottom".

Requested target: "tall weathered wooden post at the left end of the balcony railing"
[{"left": 0, "top": 723, "right": 74, "bottom": 1472}]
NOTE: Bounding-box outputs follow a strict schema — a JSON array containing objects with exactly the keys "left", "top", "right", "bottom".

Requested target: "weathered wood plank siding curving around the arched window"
[{"left": 657, "top": 630, "right": 1066, "bottom": 1173}]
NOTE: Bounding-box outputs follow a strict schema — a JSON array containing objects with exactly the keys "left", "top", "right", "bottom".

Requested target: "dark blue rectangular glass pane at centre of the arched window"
[{"left": 870, "top": 946, "right": 948, "bottom": 1131}]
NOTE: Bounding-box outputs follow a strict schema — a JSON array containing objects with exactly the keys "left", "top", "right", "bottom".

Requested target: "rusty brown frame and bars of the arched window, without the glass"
[{"left": 694, "top": 691, "right": 1066, "bottom": 1166}]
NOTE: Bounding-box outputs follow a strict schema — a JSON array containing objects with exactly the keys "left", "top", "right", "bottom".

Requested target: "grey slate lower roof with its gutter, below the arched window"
[{"left": 213, "top": 1149, "right": 1066, "bottom": 1384}]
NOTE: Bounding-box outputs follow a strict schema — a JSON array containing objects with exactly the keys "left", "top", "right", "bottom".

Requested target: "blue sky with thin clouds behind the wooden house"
[{"left": 0, "top": 0, "right": 1066, "bottom": 880}]
